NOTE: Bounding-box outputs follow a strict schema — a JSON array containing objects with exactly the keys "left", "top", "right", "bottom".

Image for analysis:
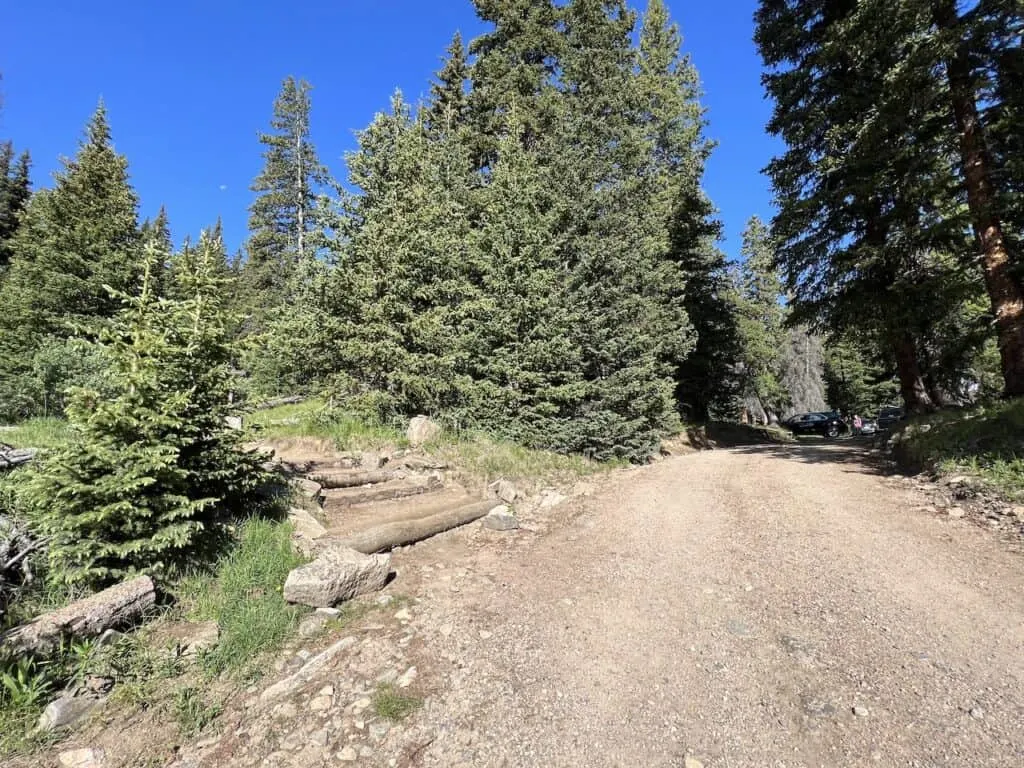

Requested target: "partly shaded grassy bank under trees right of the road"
[{"left": 895, "top": 398, "right": 1024, "bottom": 502}]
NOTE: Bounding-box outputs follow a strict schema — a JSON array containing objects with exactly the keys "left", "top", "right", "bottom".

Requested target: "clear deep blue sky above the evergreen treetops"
[{"left": 0, "top": 0, "right": 776, "bottom": 256}]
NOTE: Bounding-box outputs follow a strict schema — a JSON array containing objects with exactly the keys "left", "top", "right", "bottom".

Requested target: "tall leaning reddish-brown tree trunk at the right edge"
[{"left": 932, "top": 0, "right": 1024, "bottom": 396}]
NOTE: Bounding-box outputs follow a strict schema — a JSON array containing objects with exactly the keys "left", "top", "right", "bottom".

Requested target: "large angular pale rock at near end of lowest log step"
[{"left": 285, "top": 547, "right": 391, "bottom": 608}]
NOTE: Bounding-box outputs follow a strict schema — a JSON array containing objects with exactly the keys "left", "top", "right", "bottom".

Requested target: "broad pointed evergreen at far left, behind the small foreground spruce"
[{"left": 0, "top": 104, "right": 140, "bottom": 415}]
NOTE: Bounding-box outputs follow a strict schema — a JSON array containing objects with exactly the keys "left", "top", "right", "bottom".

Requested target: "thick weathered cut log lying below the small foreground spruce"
[{"left": 0, "top": 577, "right": 157, "bottom": 653}]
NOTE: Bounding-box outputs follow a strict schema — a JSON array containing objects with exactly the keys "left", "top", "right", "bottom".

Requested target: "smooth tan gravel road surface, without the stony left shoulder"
[{"left": 399, "top": 445, "right": 1024, "bottom": 768}]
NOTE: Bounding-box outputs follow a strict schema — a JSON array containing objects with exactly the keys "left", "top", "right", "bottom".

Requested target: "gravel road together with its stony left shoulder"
[{"left": 36, "top": 443, "right": 1024, "bottom": 768}]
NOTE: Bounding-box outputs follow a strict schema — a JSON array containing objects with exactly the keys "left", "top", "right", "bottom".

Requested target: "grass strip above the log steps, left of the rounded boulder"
[{"left": 248, "top": 399, "right": 408, "bottom": 451}]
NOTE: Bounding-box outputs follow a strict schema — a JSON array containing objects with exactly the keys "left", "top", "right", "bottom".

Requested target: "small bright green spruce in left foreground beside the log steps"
[{"left": 27, "top": 241, "right": 261, "bottom": 586}]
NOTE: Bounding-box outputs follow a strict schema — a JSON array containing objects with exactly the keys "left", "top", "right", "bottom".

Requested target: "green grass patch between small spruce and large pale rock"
[{"left": 176, "top": 518, "right": 303, "bottom": 675}]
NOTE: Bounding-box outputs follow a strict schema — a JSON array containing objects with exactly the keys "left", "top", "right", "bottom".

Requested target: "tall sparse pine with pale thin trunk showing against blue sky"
[{"left": 244, "top": 77, "right": 329, "bottom": 308}]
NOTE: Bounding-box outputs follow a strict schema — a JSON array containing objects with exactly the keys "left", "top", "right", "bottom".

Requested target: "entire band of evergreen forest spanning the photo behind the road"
[{"left": 0, "top": 0, "right": 1024, "bottom": 634}]
